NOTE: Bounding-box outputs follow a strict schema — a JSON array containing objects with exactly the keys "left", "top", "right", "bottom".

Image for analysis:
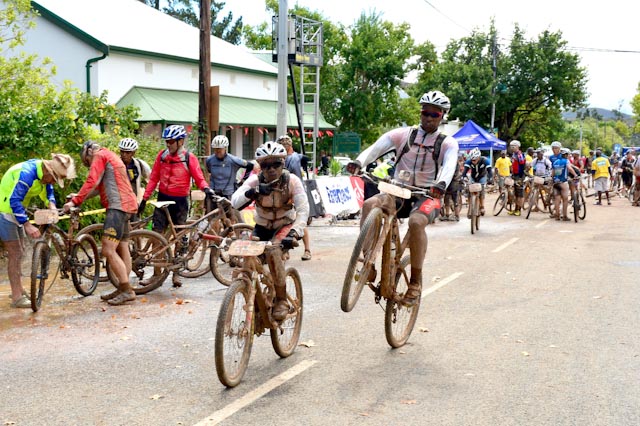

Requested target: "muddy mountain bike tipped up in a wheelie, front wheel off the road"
[{"left": 340, "top": 173, "right": 430, "bottom": 348}]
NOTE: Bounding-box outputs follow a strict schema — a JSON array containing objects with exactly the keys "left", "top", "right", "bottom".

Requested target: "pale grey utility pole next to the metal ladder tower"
[{"left": 275, "top": 0, "right": 289, "bottom": 138}]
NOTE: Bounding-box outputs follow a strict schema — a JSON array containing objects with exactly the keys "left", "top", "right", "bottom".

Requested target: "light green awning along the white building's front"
[{"left": 116, "top": 87, "right": 335, "bottom": 130}]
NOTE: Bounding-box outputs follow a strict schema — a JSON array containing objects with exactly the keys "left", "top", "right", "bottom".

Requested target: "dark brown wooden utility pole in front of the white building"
[{"left": 198, "top": 0, "right": 211, "bottom": 156}]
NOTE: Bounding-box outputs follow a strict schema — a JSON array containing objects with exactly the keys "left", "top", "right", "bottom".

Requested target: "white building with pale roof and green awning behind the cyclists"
[{"left": 17, "top": 0, "right": 334, "bottom": 157}]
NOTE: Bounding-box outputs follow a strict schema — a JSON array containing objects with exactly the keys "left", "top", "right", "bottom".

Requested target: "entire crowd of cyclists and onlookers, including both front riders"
[{"left": 0, "top": 91, "right": 640, "bottom": 310}]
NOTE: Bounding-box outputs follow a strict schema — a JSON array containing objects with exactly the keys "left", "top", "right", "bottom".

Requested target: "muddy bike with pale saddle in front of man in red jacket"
[{"left": 107, "top": 196, "right": 253, "bottom": 294}]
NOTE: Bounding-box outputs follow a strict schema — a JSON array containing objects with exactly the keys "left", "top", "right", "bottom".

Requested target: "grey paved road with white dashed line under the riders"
[{"left": 0, "top": 194, "right": 640, "bottom": 425}]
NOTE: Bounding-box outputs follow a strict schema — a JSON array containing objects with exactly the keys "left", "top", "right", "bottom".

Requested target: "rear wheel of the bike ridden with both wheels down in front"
[{"left": 269, "top": 268, "right": 302, "bottom": 358}]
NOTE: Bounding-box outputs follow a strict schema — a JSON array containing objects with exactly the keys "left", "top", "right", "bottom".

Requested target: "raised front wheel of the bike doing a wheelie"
[{"left": 340, "top": 208, "right": 383, "bottom": 312}]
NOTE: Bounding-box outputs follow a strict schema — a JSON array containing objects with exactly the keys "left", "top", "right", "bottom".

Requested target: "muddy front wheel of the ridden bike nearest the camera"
[{"left": 215, "top": 279, "right": 253, "bottom": 388}]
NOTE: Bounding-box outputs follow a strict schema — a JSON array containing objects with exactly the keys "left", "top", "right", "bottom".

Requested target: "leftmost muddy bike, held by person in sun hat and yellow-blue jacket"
[{"left": 31, "top": 207, "right": 100, "bottom": 312}]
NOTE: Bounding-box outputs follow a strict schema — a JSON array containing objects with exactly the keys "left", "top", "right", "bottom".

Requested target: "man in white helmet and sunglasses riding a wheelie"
[{"left": 347, "top": 91, "right": 458, "bottom": 305}]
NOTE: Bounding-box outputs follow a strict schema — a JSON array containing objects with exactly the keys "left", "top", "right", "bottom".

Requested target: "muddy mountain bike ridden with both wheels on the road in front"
[{"left": 209, "top": 232, "right": 303, "bottom": 387}]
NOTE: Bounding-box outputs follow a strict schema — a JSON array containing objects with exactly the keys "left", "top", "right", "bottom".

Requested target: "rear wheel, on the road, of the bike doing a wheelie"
[{"left": 384, "top": 255, "right": 421, "bottom": 348}]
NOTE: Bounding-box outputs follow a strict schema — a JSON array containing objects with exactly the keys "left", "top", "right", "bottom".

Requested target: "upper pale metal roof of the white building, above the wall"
[{"left": 31, "top": 0, "right": 278, "bottom": 76}]
